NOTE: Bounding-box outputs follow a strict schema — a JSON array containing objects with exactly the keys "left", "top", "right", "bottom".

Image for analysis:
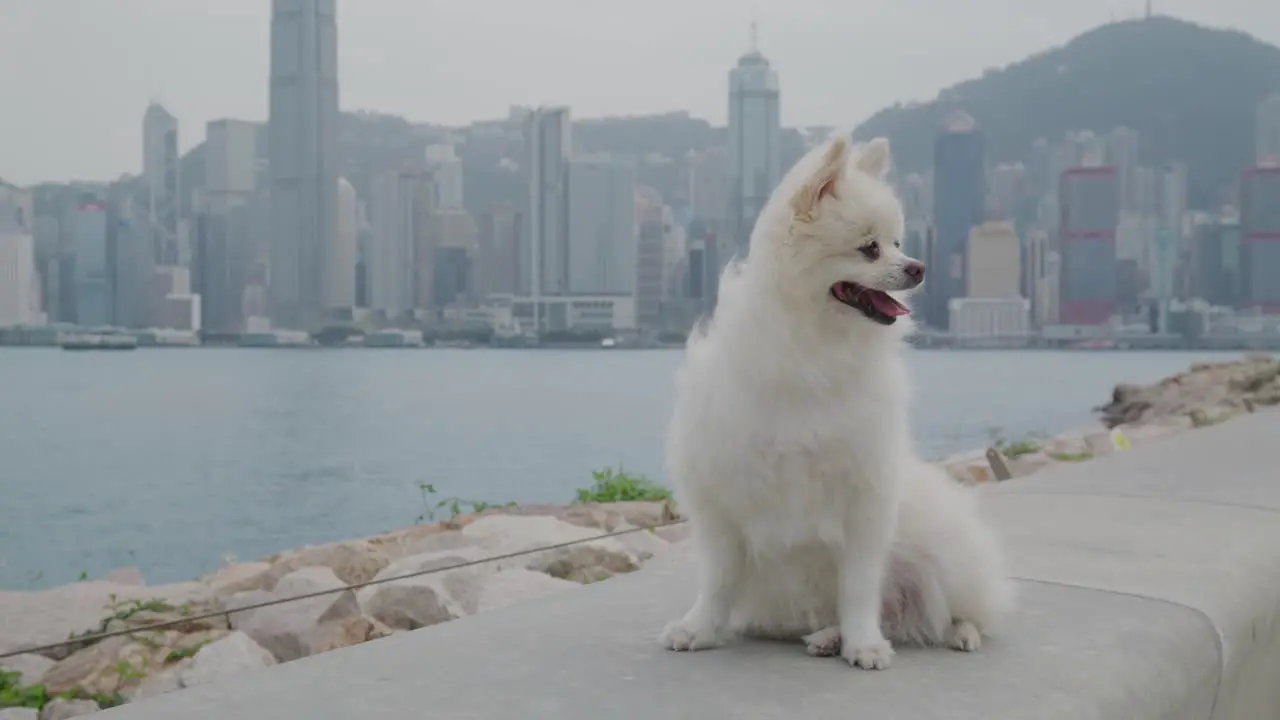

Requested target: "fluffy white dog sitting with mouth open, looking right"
[{"left": 662, "top": 131, "right": 1012, "bottom": 670}]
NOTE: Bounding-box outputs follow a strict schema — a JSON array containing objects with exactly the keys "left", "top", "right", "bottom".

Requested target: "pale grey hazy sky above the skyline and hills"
[{"left": 0, "top": 0, "right": 1280, "bottom": 184}]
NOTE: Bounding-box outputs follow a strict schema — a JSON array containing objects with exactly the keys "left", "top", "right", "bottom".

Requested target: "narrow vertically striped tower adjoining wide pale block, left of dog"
[{"left": 520, "top": 108, "right": 571, "bottom": 297}]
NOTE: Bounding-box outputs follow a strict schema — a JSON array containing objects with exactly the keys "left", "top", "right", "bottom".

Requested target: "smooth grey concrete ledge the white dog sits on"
[{"left": 108, "top": 413, "right": 1280, "bottom": 720}]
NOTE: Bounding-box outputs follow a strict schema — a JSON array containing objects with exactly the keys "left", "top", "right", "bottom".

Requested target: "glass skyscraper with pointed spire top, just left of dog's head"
[{"left": 719, "top": 23, "right": 782, "bottom": 261}]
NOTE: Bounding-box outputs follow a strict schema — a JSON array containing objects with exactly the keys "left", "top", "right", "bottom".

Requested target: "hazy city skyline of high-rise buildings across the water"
[{"left": 5, "top": 0, "right": 1280, "bottom": 342}]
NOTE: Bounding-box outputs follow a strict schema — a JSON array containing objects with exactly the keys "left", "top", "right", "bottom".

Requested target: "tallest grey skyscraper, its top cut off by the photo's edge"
[{"left": 268, "top": 0, "right": 338, "bottom": 329}]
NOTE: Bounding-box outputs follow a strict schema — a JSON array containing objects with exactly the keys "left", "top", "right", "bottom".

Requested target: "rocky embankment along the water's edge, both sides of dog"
[{"left": 0, "top": 355, "right": 1280, "bottom": 720}]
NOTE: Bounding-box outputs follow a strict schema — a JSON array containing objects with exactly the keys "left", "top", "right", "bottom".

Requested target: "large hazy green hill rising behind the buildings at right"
[{"left": 854, "top": 17, "right": 1280, "bottom": 209}]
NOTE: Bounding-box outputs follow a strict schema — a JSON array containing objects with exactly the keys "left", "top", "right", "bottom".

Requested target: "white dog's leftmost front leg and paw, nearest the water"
[{"left": 660, "top": 518, "right": 746, "bottom": 651}]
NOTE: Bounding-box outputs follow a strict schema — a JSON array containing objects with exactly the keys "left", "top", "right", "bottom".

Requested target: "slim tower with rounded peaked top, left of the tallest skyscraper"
[{"left": 142, "top": 102, "right": 186, "bottom": 265}]
